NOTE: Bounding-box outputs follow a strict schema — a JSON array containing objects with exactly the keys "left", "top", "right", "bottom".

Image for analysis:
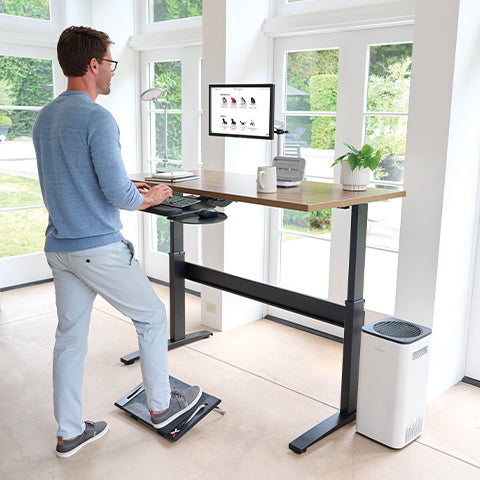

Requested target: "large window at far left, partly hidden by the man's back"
[{"left": 0, "top": 56, "right": 53, "bottom": 258}]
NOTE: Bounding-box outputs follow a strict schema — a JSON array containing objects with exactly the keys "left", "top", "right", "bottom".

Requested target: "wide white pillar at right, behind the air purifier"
[{"left": 396, "top": 0, "right": 480, "bottom": 398}]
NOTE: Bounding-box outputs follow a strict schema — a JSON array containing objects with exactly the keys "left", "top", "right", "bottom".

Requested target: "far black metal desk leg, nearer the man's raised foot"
[{"left": 120, "top": 222, "right": 212, "bottom": 365}]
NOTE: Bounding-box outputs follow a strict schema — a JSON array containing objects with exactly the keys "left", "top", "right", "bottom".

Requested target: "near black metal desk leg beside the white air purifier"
[{"left": 289, "top": 204, "right": 368, "bottom": 454}]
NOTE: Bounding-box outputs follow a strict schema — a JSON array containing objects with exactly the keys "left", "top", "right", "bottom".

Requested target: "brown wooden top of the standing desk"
[{"left": 131, "top": 170, "right": 406, "bottom": 212}]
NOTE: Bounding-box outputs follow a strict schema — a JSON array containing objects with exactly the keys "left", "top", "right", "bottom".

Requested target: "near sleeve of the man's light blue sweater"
[{"left": 87, "top": 105, "right": 143, "bottom": 210}]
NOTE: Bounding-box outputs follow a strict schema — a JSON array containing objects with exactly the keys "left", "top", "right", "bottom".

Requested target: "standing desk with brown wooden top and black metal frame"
[{"left": 128, "top": 170, "right": 406, "bottom": 454}]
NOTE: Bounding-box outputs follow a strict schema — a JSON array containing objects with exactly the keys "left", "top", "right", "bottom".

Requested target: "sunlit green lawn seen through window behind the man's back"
[{"left": 0, "top": 174, "right": 48, "bottom": 258}]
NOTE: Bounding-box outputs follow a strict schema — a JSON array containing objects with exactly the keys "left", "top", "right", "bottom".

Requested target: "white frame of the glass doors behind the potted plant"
[{"left": 268, "top": 25, "right": 413, "bottom": 336}]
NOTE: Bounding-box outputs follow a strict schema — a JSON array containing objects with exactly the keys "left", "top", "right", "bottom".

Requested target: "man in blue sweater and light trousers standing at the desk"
[{"left": 33, "top": 26, "right": 202, "bottom": 457}]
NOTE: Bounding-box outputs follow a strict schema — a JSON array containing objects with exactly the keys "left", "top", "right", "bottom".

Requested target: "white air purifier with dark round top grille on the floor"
[{"left": 357, "top": 317, "right": 432, "bottom": 448}]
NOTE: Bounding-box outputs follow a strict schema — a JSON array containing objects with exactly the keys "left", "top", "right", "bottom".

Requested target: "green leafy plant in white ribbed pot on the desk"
[{"left": 331, "top": 143, "right": 383, "bottom": 191}]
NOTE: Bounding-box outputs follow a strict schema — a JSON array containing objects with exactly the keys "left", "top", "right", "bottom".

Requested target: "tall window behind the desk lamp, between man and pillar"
[{"left": 140, "top": 47, "right": 202, "bottom": 281}]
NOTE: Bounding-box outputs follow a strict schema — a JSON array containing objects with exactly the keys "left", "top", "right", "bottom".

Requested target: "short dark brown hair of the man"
[{"left": 57, "top": 26, "right": 113, "bottom": 77}]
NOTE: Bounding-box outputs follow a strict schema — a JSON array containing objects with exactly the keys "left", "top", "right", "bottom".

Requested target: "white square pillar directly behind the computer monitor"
[{"left": 202, "top": 0, "right": 271, "bottom": 330}]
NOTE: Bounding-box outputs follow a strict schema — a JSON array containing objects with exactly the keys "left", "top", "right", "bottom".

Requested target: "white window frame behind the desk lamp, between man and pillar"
[{"left": 140, "top": 46, "right": 202, "bottom": 284}]
